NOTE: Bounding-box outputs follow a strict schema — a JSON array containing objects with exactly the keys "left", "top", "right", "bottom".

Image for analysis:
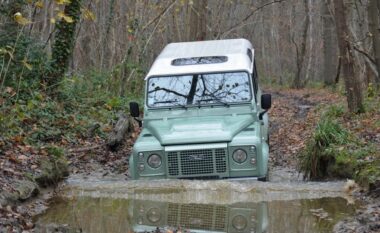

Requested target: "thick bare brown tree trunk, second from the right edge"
[{"left": 334, "top": 0, "right": 364, "bottom": 113}]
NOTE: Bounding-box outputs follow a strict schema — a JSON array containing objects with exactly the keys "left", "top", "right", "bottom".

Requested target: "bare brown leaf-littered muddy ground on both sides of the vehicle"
[{"left": 0, "top": 89, "right": 380, "bottom": 233}]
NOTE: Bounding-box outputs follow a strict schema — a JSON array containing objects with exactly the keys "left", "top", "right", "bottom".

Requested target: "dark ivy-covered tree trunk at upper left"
[{"left": 46, "top": 0, "right": 81, "bottom": 93}]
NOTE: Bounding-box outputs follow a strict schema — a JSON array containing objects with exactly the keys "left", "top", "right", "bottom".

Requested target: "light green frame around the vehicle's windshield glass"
[{"left": 144, "top": 70, "right": 256, "bottom": 109}]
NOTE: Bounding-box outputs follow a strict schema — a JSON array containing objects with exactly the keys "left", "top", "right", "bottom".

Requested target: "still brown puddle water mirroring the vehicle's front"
[{"left": 37, "top": 197, "right": 354, "bottom": 233}]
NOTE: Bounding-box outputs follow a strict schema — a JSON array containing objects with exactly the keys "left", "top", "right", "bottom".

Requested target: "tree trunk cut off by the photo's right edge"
[{"left": 368, "top": 0, "right": 380, "bottom": 85}]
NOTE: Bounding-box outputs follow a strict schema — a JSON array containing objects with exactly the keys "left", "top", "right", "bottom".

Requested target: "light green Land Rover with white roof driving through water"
[{"left": 129, "top": 39, "right": 271, "bottom": 180}]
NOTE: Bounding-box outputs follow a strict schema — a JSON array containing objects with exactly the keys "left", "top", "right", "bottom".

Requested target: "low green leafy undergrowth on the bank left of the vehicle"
[{"left": 0, "top": 72, "right": 142, "bottom": 153}]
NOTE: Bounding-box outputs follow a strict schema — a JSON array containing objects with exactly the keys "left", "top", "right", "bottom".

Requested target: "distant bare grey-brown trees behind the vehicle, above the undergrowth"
[{"left": 0, "top": 0, "right": 380, "bottom": 97}]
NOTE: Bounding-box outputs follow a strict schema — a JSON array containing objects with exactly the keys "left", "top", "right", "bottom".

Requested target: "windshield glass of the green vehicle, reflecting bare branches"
[{"left": 147, "top": 72, "right": 252, "bottom": 107}]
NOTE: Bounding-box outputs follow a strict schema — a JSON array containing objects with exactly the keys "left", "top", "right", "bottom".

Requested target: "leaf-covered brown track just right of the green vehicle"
[{"left": 266, "top": 89, "right": 340, "bottom": 168}]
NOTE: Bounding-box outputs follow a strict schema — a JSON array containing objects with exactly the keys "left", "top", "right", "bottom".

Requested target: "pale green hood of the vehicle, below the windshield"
[{"left": 144, "top": 114, "right": 254, "bottom": 145}]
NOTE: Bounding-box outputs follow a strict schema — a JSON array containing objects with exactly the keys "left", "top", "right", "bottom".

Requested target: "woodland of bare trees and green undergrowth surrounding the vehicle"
[{"left": 0, "top": 0, "right": 380, "bottom": 197}]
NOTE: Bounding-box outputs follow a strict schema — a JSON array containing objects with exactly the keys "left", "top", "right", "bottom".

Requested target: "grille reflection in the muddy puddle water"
[{"left": 168, "top": 204, "right": 227, "bottom": 231}]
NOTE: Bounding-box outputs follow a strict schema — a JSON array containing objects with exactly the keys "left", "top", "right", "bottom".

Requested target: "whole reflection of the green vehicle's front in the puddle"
[{"left": 130, "top": 200, "right": 268, "bottom": 232}]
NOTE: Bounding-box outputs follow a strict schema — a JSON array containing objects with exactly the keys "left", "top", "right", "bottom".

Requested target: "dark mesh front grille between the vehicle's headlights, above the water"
[{"left": 167, "top": 148, "right": 227, "bottom": 177}]
